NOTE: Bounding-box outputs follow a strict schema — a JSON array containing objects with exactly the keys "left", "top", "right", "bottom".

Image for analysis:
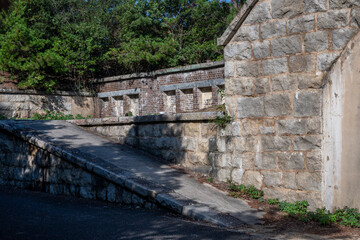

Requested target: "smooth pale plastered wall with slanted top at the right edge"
[{"left": 323, "top": 34, "right": 360, "bottom": 209}]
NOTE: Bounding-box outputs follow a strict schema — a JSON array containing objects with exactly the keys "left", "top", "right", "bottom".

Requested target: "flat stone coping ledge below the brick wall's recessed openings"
[{"left": 68, "top": 112, "right": 219, "bottom": 126}]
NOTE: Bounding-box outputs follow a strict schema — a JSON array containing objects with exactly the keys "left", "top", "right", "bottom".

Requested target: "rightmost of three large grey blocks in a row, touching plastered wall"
[{"left": 294, "top": 92, "right": 321, "bottom": 117}]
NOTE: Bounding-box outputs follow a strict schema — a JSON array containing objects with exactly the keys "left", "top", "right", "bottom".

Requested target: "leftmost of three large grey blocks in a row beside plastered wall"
[{"left": 237, "top": 97, "right": 264, "bottom": 118}]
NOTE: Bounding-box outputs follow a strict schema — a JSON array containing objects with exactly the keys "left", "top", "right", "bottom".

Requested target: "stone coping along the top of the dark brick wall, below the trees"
[{"left": 93, "top": 61, "right": 225, "bottom": 84}]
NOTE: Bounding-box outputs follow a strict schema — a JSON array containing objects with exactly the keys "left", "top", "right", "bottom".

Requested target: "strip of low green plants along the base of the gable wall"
[{"left": 229, "top": 182, "right": 360, "bottom": 228}]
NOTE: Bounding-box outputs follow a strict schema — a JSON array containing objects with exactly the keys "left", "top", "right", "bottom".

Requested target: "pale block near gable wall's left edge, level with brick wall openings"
[{"left": 228, "top": 77, "right": 255, "bottom": 96}]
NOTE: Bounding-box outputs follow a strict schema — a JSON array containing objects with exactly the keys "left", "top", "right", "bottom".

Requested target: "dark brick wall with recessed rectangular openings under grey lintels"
[{"left": 95, "top": 62, "right": 225, "bottom": 118}]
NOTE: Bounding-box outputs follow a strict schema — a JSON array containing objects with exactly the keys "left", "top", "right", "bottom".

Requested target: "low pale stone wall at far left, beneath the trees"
[{"left": 0, "top": 89, "right": 97, "bottom": 118}]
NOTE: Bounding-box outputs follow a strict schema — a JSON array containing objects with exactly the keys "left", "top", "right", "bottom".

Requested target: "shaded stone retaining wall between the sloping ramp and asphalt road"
[{"left": 0, "top": 123, "right": 156, "bottom": 208}]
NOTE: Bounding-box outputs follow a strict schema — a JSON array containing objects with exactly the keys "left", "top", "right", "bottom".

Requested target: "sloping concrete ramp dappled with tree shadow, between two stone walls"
[{"left": 0, "top": 121, "right": 264, "bottom": 226}]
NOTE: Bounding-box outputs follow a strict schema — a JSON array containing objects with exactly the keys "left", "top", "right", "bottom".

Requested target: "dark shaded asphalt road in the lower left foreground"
[{"left": 0, "top": 187, "right": 262, "bottom": 240}]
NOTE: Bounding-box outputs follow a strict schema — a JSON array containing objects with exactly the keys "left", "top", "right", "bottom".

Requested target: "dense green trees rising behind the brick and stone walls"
[{"left": 0, "top": 0, "right": 243, "bottom": 90}]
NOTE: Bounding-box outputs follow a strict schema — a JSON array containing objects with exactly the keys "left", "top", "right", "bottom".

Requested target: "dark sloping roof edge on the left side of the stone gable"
[{"left": 217, "top": 0, "right": 259, "bottom": 46}]
